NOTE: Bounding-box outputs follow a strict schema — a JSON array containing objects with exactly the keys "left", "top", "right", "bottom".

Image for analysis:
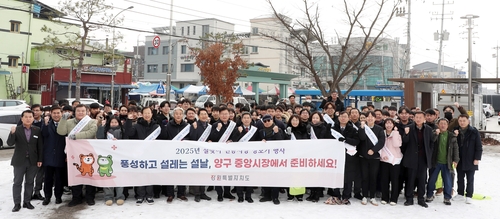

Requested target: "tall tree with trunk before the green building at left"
[{"left": 42, "top": 0, "right": 119, "bottom": 100}]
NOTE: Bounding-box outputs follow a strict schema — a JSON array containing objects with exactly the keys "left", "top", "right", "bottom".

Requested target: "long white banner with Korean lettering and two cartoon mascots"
[{"left": 66, "top": 139, "right": 345, "bottom": 188}]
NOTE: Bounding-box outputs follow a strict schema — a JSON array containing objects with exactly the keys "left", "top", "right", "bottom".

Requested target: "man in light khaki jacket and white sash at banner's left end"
[{"left": 57, "top": 104, "right": 97, "bottom": 207}]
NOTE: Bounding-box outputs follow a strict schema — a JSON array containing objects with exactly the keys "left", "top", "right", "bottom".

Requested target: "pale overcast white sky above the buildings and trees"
[{"left": 41, "top": 0, "right": 500, "bottom": 81}]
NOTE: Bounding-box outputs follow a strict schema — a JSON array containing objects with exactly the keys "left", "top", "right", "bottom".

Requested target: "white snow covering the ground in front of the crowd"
[{"left": 0, "top": 146, "right": 500, "bottom": 219}]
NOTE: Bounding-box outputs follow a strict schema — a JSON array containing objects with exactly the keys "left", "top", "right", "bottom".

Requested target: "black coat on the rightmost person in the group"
[{"left": 457, "top": 125, "right": 483, "bottom": 171}]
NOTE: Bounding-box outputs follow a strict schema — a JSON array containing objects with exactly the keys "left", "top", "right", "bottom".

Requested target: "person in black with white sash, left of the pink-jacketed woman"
[{"left": 357, "top": 111, "right": 385, "bottom": 206}]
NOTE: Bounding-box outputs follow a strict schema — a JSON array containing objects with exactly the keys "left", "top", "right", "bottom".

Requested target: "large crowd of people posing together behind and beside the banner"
[{"left": 7, "top": 93, "right": 482, "bottom": 212}]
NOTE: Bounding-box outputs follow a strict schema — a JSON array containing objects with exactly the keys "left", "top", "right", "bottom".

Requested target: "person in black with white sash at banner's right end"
[{"left": 325, "top": 111, "right": 359, "bottom": 205}]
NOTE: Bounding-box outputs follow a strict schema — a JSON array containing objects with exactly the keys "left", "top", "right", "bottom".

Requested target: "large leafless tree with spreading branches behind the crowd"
[{"left": 262, "top": 0, "right": 399, "bottom": 96}]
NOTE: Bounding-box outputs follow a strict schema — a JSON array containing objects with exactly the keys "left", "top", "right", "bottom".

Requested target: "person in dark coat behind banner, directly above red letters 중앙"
[{"left": 258, "top": 114, "right": 285, "bottom": 205}]
